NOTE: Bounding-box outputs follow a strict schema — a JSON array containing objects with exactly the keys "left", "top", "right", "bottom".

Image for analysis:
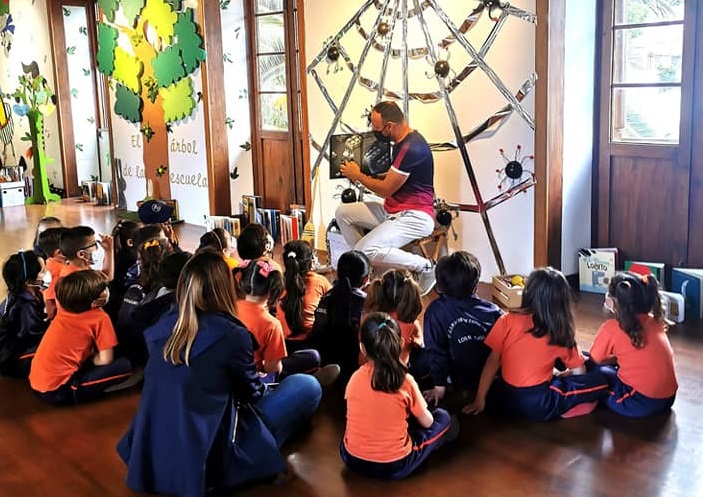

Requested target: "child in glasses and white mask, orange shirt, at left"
[{"left": 44, "top": 226, "right": 115, "bottom": 319}]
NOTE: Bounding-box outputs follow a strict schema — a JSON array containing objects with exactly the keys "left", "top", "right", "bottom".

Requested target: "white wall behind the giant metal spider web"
[{"left": 305, "top": 0, "right": 541, "bottom": 281}]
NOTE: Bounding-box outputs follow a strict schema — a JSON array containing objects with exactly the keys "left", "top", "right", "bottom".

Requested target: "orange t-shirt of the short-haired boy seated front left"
[{"left": 29, "top": 308, "right": 117, "bottom": 392}]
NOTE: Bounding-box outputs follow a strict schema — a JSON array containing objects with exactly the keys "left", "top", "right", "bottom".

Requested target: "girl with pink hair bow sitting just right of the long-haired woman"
[{"left": 235, "top": 259, "right": 328, "bottom": 383}]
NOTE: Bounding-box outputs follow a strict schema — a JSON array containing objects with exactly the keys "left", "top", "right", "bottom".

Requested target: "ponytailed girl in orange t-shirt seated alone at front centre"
[{"left": 340, "top": 312, "right": 459, "bottom": 480}]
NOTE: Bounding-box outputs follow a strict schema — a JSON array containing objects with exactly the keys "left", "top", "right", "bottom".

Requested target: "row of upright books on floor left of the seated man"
[{"left": 205, "top": 195, "right": 305, "bottom": 245}]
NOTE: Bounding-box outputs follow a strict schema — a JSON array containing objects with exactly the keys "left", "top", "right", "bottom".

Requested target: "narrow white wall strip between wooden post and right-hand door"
[{"left": 561, "top": 0, "right": 596, "bottom": 274}]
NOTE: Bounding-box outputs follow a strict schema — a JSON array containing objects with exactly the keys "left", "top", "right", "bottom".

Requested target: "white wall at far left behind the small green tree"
[{"left": 0, "top": 0, "right": 63, "bottom": 187}]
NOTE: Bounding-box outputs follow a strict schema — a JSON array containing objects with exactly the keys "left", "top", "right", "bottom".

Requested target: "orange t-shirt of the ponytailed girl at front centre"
[{"left": 344, "top": 361, "right": 427, "bottom": 463}]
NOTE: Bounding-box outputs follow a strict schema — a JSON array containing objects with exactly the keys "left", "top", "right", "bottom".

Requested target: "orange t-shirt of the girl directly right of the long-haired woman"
[{"left": 237, "top": 300, "right": 288, "bottom": 371}]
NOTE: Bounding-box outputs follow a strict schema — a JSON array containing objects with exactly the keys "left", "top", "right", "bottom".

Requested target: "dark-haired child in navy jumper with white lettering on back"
[{"left": 423, "top": 251, "right": 503, "bottom": 404}]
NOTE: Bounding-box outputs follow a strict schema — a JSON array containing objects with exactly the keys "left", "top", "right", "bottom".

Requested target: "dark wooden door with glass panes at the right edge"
[{"left": 594, "top": 0, "right": 700, "bottom": 265}]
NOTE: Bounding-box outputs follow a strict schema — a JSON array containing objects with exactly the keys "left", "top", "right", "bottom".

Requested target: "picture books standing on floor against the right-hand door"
[{"left": 578, "top": 248, "right": 703, "bottom": 322}]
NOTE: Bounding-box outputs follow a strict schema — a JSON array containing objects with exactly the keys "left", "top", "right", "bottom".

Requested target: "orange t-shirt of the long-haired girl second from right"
[{"left": 484, "top": 312, "right": 584, "bottom": 387}]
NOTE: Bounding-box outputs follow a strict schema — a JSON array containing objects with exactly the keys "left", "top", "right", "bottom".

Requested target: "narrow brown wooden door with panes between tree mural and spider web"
[{"left": 247, "top": 0, "right": 305, "bottom": 212}]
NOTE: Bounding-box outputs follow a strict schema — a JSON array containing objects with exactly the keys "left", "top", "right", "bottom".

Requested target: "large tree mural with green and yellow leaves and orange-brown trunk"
[{"left": 96, "top": 0, "right": 205, "bottom": 199}]
